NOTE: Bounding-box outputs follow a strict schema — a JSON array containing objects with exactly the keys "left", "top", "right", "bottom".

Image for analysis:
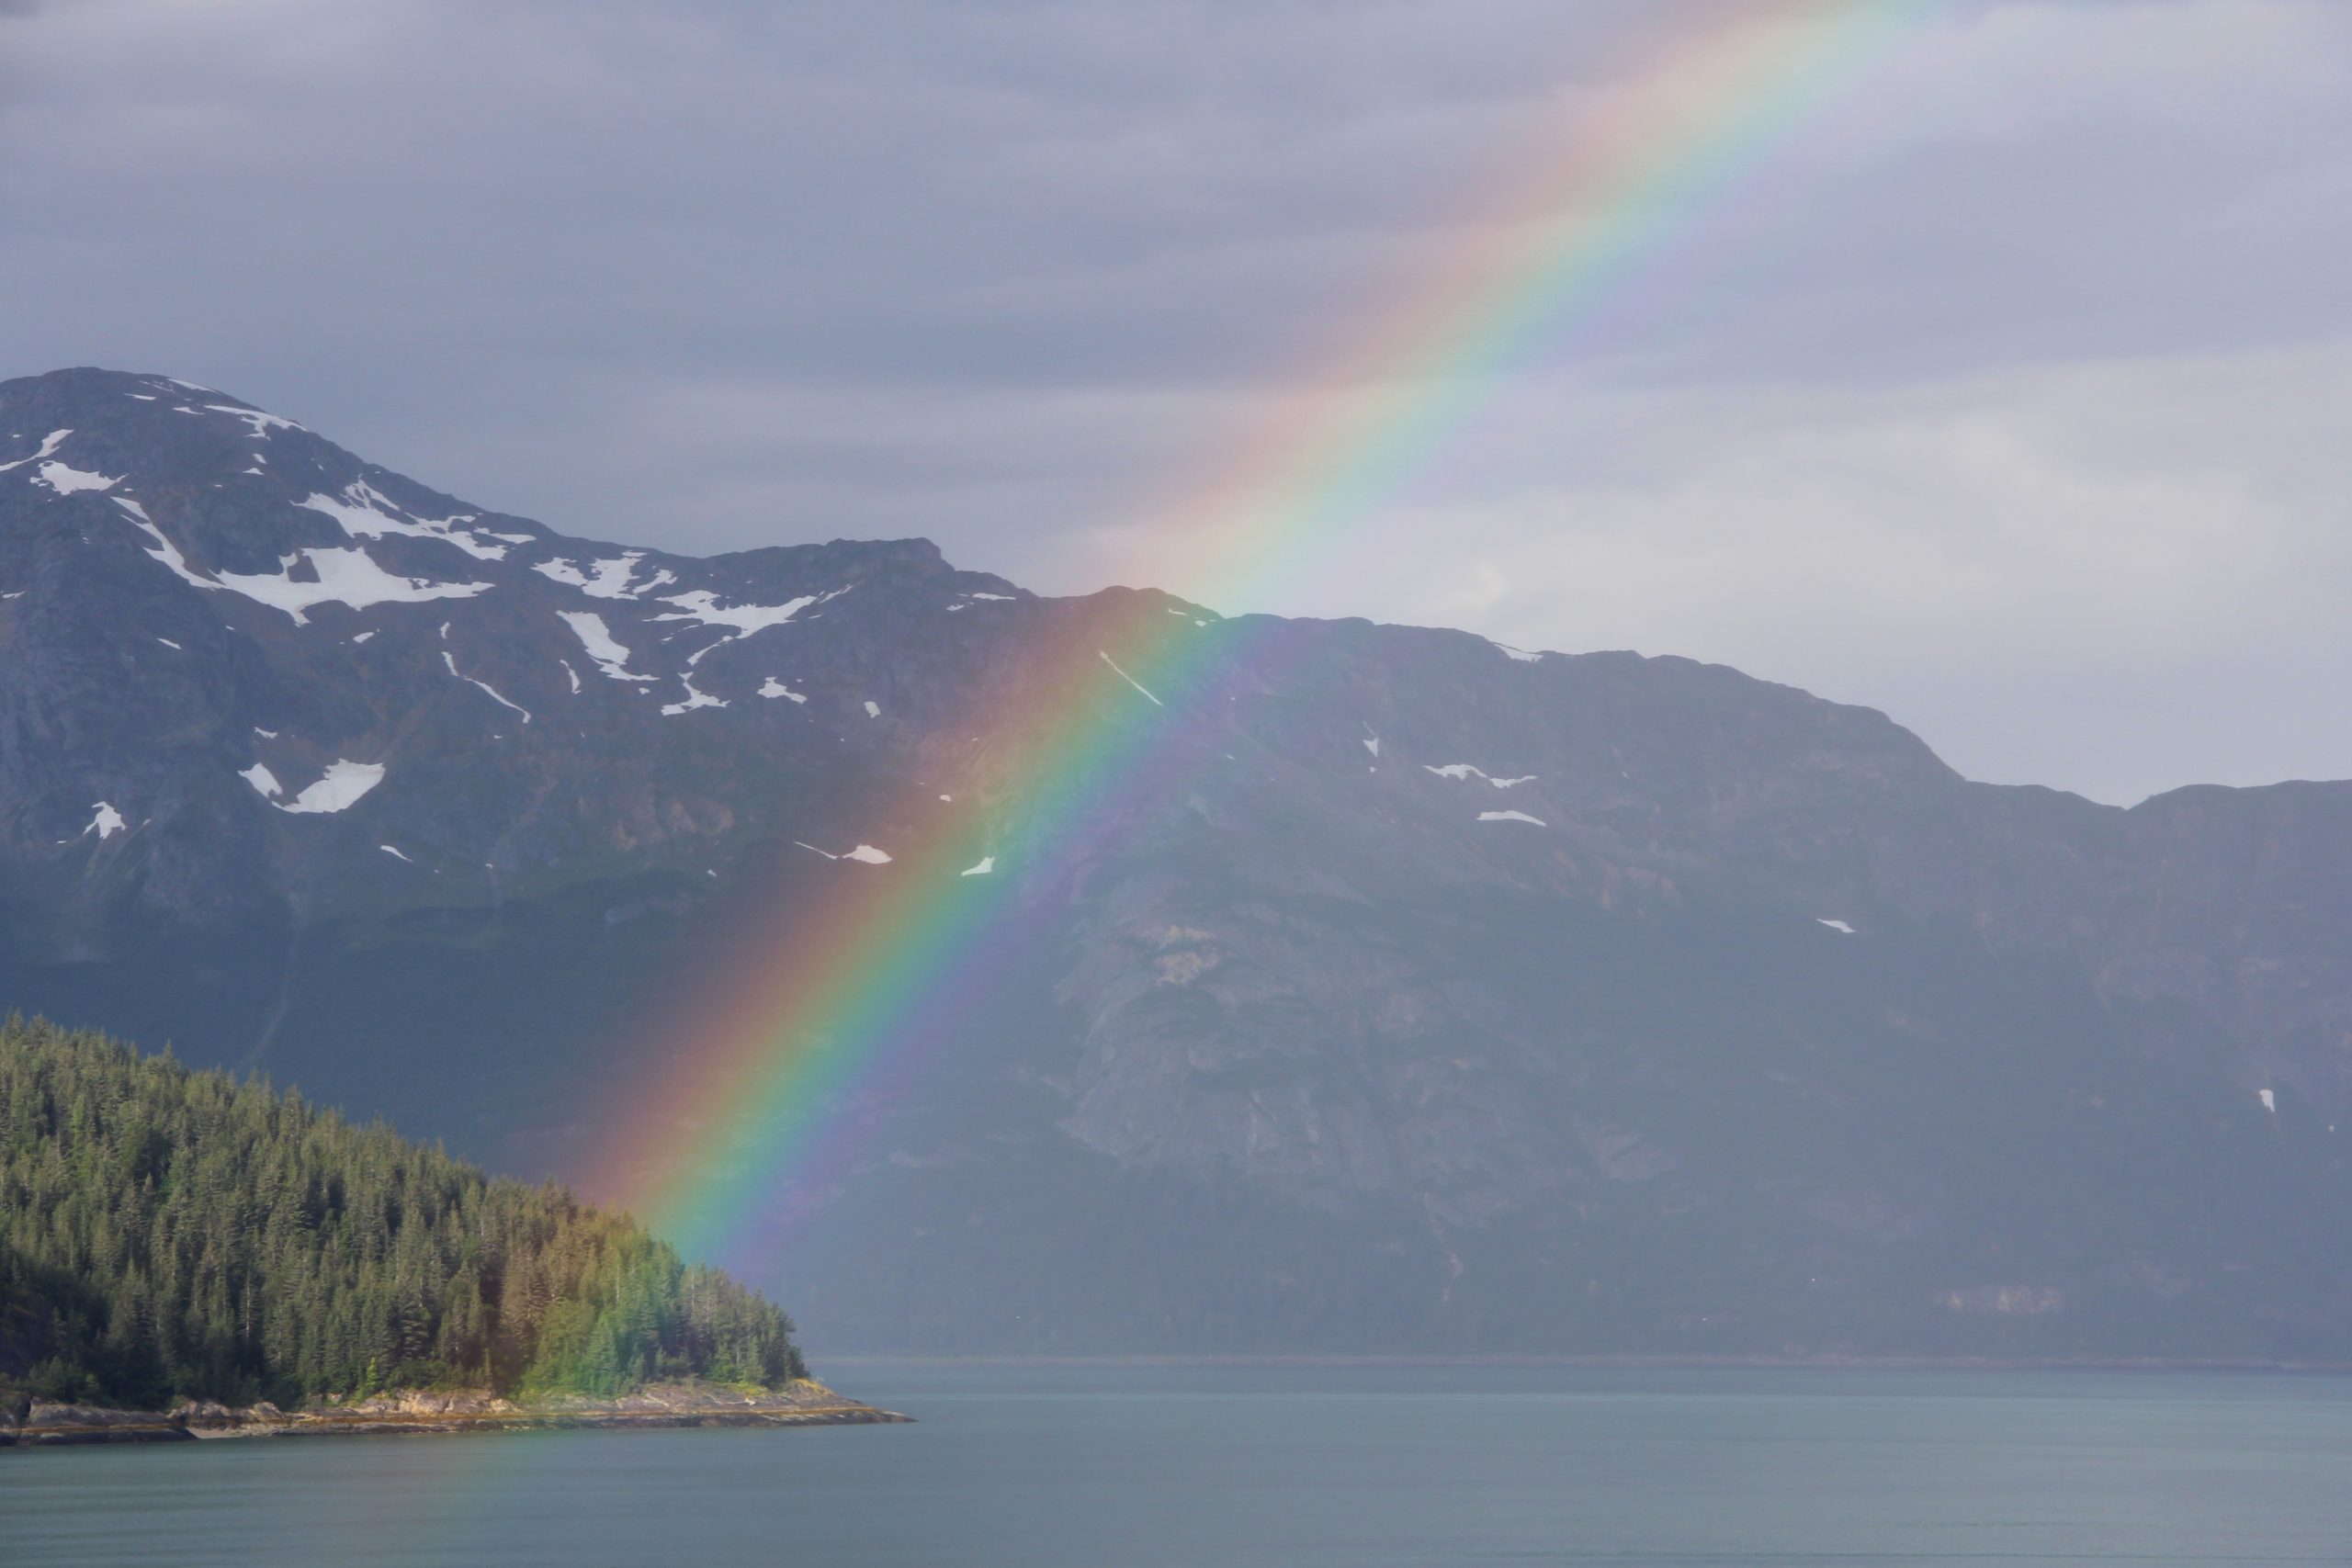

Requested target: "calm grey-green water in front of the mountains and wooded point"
[{"left": 0, "top": 1363, "right": 2352, "bottom": 1568}]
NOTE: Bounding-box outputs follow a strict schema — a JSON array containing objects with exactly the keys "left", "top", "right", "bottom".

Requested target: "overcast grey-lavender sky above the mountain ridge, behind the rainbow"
[{"left": 0, "top": 0, "right": 2352, "bottom": 804}]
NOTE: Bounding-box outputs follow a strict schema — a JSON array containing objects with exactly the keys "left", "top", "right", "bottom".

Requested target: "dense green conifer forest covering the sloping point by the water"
[{"left": 0, "top": 1018, "right": 807, "bottom": 1408}]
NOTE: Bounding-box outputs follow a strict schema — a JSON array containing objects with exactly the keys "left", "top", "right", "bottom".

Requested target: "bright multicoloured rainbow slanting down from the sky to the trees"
[{"left": 591, "top": 0, "right": 1943, "bottom": 1269}]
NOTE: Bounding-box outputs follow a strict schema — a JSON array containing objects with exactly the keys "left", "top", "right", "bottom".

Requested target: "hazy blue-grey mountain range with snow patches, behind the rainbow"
[{"left": 0, "top": 369, "right": 2352, "bottom": 1359}]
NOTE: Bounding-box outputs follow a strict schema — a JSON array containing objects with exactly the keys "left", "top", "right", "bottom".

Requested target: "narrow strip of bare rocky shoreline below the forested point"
[{"left": 0, "top": 1380, "right": 912, "bottom": 1448}]
